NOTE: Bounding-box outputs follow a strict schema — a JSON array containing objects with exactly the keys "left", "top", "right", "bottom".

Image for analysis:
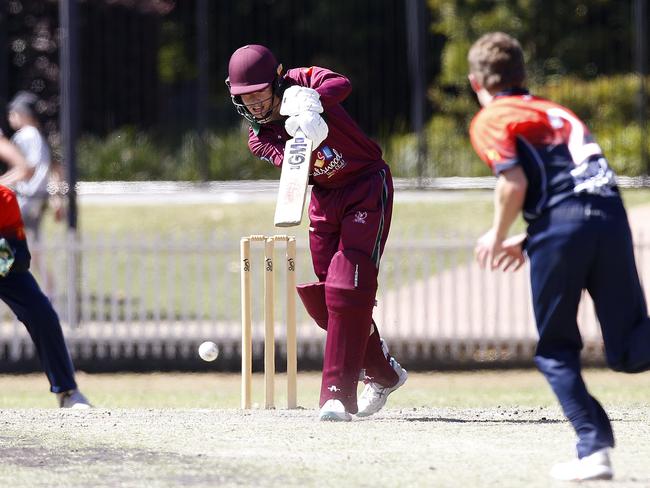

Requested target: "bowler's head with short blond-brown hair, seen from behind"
[{"left": 467, "top": 32, "right": 526, "bottom": 93}]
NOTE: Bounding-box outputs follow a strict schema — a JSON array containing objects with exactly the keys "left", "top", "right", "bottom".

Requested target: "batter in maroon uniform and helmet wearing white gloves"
[{"left": 227, "top": 45, "right": 408, "bottom": 421}]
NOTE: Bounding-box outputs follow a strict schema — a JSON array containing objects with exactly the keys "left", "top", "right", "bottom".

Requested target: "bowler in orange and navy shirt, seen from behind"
[{"left": 468, "top": 32, "right": 650, "bottom": 481}]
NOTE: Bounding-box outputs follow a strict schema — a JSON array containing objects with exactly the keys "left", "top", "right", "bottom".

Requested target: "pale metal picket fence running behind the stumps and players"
[{"left": 0, "top": 229, "right": 650, "bottom": 371}]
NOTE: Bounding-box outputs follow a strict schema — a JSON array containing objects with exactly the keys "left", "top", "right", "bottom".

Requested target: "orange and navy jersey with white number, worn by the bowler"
[{"left": 470, "top": 90, "right": 618, "bottom": 222}]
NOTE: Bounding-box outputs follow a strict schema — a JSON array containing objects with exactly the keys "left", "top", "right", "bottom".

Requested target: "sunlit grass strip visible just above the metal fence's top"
[{"left": 39, "top": 189, "right": 650, "bottom": 239}]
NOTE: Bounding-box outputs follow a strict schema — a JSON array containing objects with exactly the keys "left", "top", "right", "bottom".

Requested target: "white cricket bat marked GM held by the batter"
[{"left": 274, "top": 130, "right": 313, "bottom": 227}]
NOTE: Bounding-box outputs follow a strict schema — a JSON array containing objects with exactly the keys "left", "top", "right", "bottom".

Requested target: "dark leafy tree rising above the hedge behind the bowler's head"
[{"left": 429, "top": 0, "right": 634, "bottom": 84}]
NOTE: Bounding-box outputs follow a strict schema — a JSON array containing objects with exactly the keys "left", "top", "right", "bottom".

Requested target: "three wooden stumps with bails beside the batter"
[{"left": 240, "top": 235, "right": 298, "bottom": 409}]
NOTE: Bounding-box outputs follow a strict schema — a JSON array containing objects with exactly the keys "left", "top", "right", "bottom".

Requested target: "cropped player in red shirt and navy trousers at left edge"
[{"left": 0, "top": 183, "right": 90, "bottom": 408}]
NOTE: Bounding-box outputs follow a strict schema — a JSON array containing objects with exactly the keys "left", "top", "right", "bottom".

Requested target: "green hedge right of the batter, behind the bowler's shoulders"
[{"left": 385, "top": 75, "right": 650, "bottom": 177}]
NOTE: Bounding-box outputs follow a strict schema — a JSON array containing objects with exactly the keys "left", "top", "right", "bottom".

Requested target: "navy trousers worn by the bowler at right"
[{"left": 527, "top": 195, "right": 650, "bottom": 457}]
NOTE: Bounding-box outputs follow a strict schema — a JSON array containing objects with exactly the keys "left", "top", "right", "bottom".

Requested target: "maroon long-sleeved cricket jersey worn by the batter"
[{"left": 248, "top": 66, "right": 387, "bottom": 189}]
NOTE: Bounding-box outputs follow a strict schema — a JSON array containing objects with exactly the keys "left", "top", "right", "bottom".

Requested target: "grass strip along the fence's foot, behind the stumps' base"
[{"left": 0, "top": 369, "right": 650, "bottom": 409}]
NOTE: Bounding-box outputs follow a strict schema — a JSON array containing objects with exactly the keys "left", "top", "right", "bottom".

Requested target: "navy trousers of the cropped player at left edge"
[{"left": 0, "top": 271, "right": 77, "bottom": 393}]
